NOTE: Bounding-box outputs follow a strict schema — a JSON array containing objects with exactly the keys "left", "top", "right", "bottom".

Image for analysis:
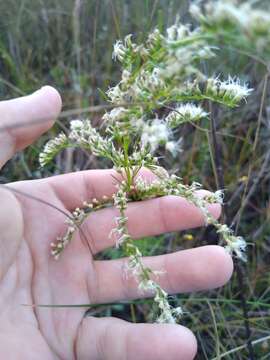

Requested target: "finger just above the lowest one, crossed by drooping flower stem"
[{"left": 87, "top": 245, "right": 233, "bottom": 303}]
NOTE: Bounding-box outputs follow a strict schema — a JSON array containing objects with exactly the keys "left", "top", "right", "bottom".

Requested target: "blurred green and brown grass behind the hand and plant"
[{"left": 0, "top": 0, "right": 270, "bottom": 360}]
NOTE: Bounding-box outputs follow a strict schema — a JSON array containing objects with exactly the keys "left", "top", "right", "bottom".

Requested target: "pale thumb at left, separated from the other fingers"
[{"left": 0, "top": 86, "right": 61, "bottom": 167}]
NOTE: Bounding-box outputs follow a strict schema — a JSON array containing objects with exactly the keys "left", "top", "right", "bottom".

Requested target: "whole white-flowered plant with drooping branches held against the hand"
[{"left": 40, "top": 1, "right": 258, "bottom": 323}]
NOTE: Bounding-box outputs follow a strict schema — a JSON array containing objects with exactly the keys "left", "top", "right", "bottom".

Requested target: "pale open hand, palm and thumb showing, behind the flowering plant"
[{"left": 0, "top": 87, "right": 233, "bottom": 360}]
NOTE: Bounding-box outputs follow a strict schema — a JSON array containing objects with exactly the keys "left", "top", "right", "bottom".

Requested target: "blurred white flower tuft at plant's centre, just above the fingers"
[{"left": 141, "top": 119, "right": 170, "bottom": 152}]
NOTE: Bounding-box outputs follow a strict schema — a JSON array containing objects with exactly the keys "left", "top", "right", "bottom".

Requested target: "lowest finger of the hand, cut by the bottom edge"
[{"left": 75, "top": 317, "right": 197, "bottom": 360}]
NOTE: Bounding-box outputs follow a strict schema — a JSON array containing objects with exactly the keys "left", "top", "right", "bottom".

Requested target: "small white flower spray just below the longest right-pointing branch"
[{"left": 165, "top": 103, "right": 208, "bottom": 128}]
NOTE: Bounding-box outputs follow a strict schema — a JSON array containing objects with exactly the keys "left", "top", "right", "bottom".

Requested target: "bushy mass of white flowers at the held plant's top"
[{"left": 107, "top": 24, "right": 213, "bottom": 104}]
